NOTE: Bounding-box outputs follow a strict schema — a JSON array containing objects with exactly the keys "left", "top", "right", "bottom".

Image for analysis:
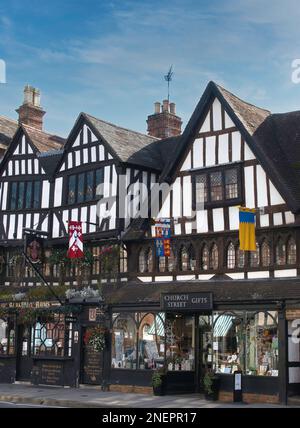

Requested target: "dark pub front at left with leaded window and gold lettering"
[{"left": 0, "top": 300, "right": 106, "bottom": 387}]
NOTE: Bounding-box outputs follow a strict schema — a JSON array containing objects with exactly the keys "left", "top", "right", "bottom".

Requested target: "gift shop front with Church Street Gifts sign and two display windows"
[{"left": 109, "top": 282, "right": 286, "bottom": 403}]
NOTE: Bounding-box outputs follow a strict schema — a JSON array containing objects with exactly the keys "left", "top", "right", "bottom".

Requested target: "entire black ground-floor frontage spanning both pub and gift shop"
[{"left": 0, "top": 281, "right": 300, "bottom": 403}]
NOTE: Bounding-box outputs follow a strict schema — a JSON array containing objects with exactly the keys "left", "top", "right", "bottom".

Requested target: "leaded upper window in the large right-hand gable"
[{"left": 194, "top": 166, "right": 242, "bottom": 207}]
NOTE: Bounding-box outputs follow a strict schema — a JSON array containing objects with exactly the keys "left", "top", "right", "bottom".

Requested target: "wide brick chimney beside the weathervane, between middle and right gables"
[{"left": 147, "top": 100, "right": 182, "bottom": 138}]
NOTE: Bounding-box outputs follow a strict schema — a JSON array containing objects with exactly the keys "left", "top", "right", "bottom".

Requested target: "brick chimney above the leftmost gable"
[{"left": 16, "top": 85, "right": 46, "bottom": 130}]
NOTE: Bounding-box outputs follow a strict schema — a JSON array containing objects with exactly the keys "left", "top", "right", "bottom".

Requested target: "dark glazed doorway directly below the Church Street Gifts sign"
[{"left": 166, "top": 315, "right": 195, "bottom": 371}]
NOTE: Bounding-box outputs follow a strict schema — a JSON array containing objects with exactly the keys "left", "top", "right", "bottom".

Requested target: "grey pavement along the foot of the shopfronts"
[{"left": 0, "top": 384, "right": 285, "bottom": 409}]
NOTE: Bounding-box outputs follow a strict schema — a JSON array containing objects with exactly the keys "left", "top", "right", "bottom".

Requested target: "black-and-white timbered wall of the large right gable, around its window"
[{"left": 152, "top": 97, "right": 295, "bottom": 239}]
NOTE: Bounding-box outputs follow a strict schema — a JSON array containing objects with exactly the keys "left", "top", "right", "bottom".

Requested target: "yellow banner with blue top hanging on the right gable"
[{"left": 239, "top": 208, "right": 256, "bottom": 251}]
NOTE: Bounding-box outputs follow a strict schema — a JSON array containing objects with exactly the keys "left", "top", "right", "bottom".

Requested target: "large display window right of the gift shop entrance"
[{"left": 213, "top": 312, "right": 279, "bottom": 376}]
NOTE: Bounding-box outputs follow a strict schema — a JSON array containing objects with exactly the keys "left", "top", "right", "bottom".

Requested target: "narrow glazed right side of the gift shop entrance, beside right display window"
[{"left": 197, "top": 317, "right": 213, "bottom": 392}]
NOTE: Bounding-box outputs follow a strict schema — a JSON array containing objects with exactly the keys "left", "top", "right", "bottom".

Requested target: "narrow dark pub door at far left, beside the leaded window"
[{"left": 16, "top": 325, "right": 32, "bottom": 381}]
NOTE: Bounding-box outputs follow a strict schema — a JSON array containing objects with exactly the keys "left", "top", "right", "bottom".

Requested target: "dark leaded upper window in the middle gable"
[{"left": 67, "top": 168, "right": 104, "bottom": 205}]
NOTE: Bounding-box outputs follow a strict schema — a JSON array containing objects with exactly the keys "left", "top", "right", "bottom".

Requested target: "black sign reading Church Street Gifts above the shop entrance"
[{"left": 161, "top": 293, "right": 213, "bottom": 311}]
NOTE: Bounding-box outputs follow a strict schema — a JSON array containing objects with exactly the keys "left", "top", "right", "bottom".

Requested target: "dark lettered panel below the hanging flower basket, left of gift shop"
[{"left": 81, "top": 328, "right": 103, "bottom": 385}]
